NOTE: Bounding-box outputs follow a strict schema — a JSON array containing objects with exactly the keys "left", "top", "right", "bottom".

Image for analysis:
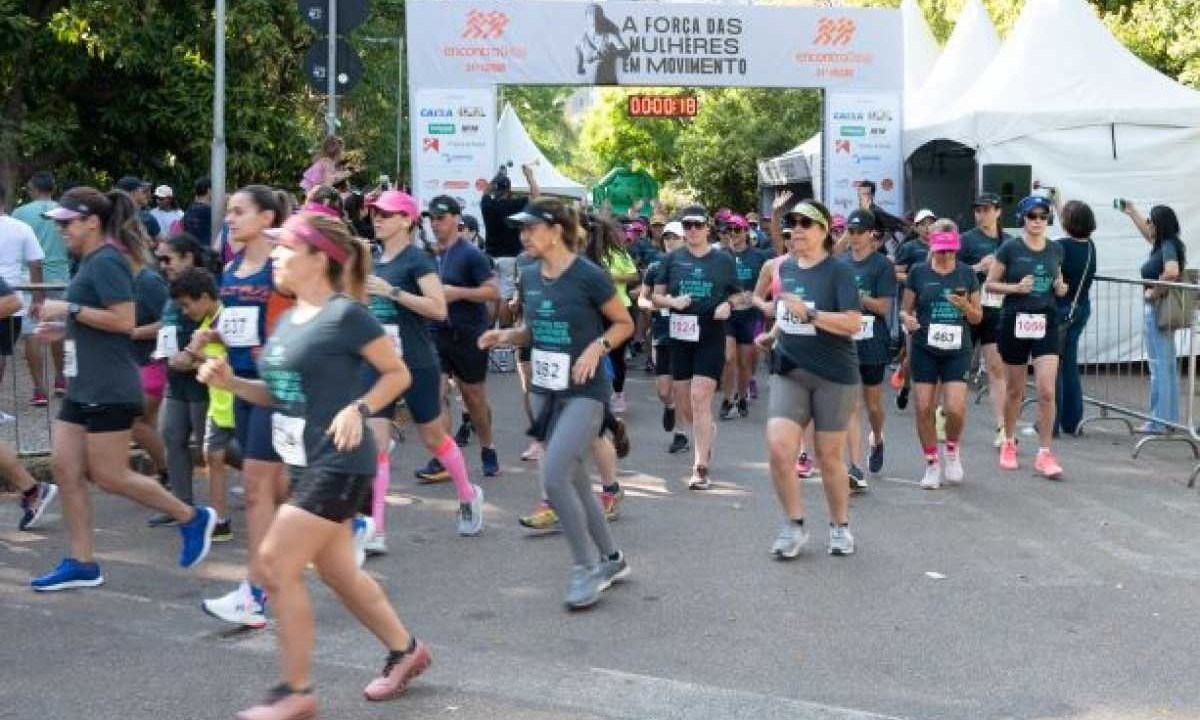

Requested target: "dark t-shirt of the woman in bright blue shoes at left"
[{"left": 66, "top": 245, "right": 142, "bottom": 404}]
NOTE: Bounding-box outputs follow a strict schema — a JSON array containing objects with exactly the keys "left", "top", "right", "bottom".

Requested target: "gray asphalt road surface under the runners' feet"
[{"left": 0, "top": 364, "right": 1200, "bottom": 720}]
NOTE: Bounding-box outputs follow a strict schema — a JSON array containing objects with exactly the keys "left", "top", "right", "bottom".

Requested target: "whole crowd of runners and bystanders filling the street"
[{"left": 0, "top": 143, "right": 1184, "bottom": 720}]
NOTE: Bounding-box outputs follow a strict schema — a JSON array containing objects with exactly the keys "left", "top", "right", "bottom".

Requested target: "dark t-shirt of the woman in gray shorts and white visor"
[{"left": 775, "top": 256, "right": 862, "bottom": 385}]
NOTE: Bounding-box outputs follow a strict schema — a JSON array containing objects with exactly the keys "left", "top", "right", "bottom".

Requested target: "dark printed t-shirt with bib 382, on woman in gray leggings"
[{"left": 521, "top": 256, "right": 617, "bottom": 402}]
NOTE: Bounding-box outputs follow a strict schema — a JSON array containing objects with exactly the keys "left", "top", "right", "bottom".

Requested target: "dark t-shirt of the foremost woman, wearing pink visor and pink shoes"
[{"left": 258, "top": 295, "right": 384, "bottom": 475}]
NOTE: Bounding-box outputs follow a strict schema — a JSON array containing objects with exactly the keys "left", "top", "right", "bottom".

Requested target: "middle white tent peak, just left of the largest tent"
[{"left": 905, "top": 0, "right": 1000, "bottom": 126}]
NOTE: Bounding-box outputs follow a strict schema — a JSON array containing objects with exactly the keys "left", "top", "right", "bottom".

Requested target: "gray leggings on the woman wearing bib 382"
[{"left": 540, "top": 392, "right": 617, "bottom": 565}]
